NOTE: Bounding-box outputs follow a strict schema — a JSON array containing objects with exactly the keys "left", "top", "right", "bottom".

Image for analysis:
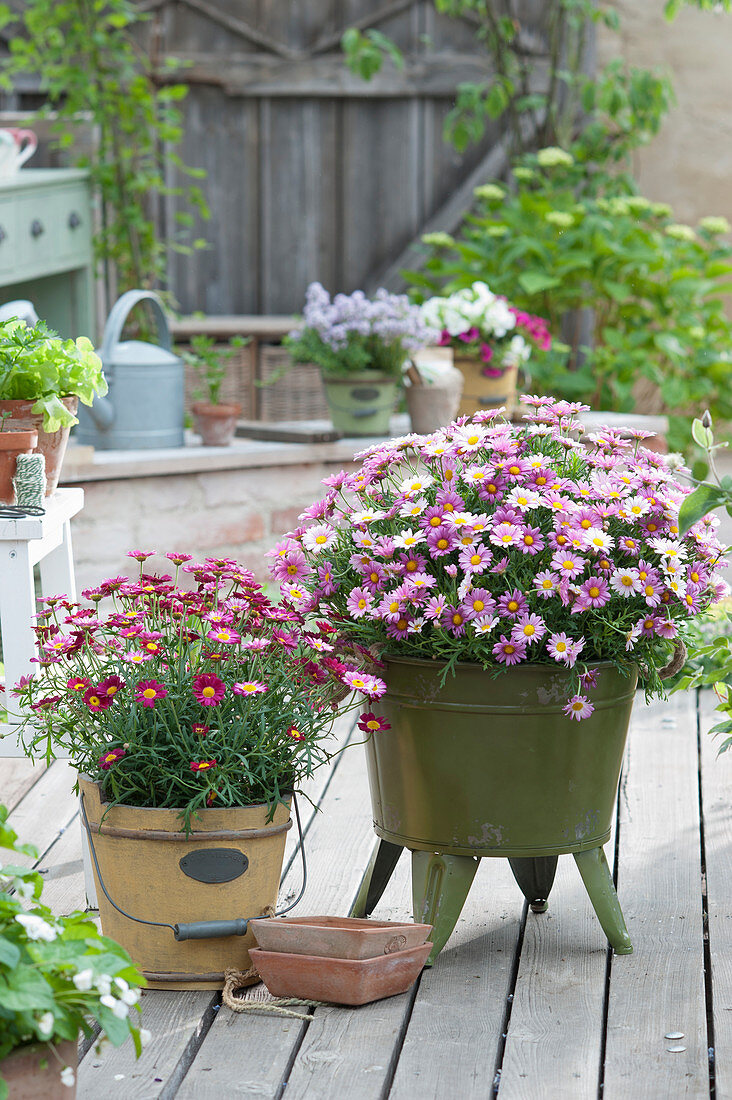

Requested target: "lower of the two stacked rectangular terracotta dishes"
[{"left": 249, "top": 943, "right": 433, "bottom": 1004}]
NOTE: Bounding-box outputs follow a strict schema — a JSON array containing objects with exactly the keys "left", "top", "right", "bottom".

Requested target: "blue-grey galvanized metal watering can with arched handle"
[{"left": 76, "top": 290, "right": 184, "bottom": 451}]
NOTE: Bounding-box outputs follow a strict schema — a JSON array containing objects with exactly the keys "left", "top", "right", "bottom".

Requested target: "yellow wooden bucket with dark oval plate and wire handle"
[{"left": 79, "top": 777, "right": 292, "bottom": 989}]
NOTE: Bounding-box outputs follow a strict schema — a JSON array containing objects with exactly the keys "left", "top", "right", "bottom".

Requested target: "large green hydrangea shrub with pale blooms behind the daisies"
[{"left": 407, "top": 147, "right": 732, "bottom": 448}]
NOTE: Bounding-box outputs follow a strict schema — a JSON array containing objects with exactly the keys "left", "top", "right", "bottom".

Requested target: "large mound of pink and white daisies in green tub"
[{"left": 272, "top": 396, "right": 726, "bottom": 721}]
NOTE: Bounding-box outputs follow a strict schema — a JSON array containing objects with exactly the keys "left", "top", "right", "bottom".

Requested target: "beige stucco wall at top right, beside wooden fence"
[{"left": 598, "top": 0, "right": 732, "bottom": 224}]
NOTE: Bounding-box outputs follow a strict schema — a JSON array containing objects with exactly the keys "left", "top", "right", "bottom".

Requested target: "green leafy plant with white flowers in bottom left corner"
[{"left": 0, "top": 804, "right": 146, "bottom": 1082}]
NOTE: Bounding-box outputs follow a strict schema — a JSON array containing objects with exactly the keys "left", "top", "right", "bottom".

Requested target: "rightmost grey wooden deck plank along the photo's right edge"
[{"left": 700, "top": 691, "right": 732, "bottom": 1097}]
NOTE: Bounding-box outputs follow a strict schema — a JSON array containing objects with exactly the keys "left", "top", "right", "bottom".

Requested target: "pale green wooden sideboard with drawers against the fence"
[{"left": 0, "top": 168, "right": 97, "bottom": 340}]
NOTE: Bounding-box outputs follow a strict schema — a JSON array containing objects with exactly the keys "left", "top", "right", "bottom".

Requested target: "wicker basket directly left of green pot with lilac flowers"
[{"left": 256, "top": 344, "right": 330, "bottom": 421}]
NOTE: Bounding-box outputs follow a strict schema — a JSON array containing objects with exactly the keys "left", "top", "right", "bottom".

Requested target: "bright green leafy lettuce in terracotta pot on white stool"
[{"left": 0, "top": 318, "right": 107, "bottom": 431}]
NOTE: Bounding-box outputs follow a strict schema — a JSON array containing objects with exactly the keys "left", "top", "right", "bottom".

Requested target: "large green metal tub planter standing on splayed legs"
[{"left": 351, "top": 657, "right": 637, "bottom": 963}]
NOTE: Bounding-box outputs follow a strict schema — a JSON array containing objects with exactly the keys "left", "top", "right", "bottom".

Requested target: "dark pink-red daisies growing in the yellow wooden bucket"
[{"left": 12, "top": 554, "right": 385, "bottom": 820}]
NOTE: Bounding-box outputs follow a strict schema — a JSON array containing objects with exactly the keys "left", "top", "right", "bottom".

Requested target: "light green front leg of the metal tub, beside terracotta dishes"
[{"left": 412, "top": 851, "right": 480, "bottom": 966}]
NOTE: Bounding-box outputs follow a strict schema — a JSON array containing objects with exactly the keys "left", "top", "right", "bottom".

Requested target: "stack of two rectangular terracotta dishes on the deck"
[{"left": 249, "top": 916, "right": 433, "bottom": 1004}]
